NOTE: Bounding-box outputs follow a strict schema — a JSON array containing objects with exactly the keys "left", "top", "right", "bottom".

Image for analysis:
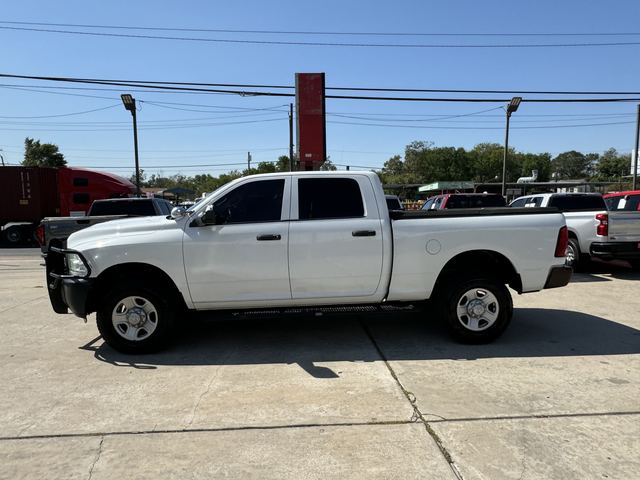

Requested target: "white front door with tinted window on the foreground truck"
[{"left": 183, "top": 177, "right": 291, "bottom": 308}]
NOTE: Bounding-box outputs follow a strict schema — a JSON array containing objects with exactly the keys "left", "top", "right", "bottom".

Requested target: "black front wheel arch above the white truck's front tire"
[{"left": 87, "top": 262, "right": 187, "bottom": 313}]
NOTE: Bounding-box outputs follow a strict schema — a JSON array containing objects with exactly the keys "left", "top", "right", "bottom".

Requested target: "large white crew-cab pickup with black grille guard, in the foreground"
[{"left": 46, "top": 172, "right": 571, "bottom": 353}]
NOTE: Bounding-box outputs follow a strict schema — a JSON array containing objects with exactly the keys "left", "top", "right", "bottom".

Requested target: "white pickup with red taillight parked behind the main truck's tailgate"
[{"left": 511, "top": 193, "right": 640, "bottom": 268}]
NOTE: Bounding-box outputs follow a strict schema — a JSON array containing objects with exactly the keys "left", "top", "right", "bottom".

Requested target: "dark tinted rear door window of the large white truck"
[{"left": 298, "top": 178, "right": 364, "bottom": 220}]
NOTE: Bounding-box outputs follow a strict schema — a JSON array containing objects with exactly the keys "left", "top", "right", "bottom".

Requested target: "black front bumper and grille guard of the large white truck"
[{"left": 45, "top": 247, "right": 95, "bottom": 318}]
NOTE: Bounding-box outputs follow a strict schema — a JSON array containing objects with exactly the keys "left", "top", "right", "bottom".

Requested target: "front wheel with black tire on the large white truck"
[{"left": 96, "top": 283, "right": 177, "bottom": 354}]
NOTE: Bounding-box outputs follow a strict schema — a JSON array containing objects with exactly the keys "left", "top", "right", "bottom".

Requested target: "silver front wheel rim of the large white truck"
[{"left": 111, "top": 296, "right": 158, "bottom": 342}]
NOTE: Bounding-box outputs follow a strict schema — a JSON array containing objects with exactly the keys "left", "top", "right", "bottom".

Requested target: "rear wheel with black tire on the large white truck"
[{"left": 441, "top": 275, "right": 513, "bottom": 344}]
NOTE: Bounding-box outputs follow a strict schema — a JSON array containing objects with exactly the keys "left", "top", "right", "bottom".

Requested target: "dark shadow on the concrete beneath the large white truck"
[{"left": 86, "top": 308, "right": 640, "bottom": 379}]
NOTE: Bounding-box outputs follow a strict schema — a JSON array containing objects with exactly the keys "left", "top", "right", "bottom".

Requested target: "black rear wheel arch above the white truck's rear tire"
[{"left": 433, "top": 250, "right": 522, "bottom": 293}]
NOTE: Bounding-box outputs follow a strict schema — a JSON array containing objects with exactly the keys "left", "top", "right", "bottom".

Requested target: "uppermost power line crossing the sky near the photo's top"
[{"left": 0, "top": 21, "right": 640, "bottom": 37}]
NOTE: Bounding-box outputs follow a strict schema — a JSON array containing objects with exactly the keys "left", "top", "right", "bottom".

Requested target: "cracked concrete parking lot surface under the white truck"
[{"left": 0, "top": 249, "right": 640, "bottom": 479}]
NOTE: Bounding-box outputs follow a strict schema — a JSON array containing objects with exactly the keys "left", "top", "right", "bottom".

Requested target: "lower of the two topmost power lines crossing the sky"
[{"left": 0, "top": 25, "right": 640, "bottom": 49}]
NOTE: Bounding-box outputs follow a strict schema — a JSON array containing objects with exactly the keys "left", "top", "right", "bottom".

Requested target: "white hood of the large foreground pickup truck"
[{"left": 67, "top": 215, "right": 185, "bottom": 250}]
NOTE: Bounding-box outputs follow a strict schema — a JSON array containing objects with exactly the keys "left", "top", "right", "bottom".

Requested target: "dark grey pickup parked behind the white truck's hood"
[{"left": 36, "top": 198, "right": 173, "bottom": 253}]
